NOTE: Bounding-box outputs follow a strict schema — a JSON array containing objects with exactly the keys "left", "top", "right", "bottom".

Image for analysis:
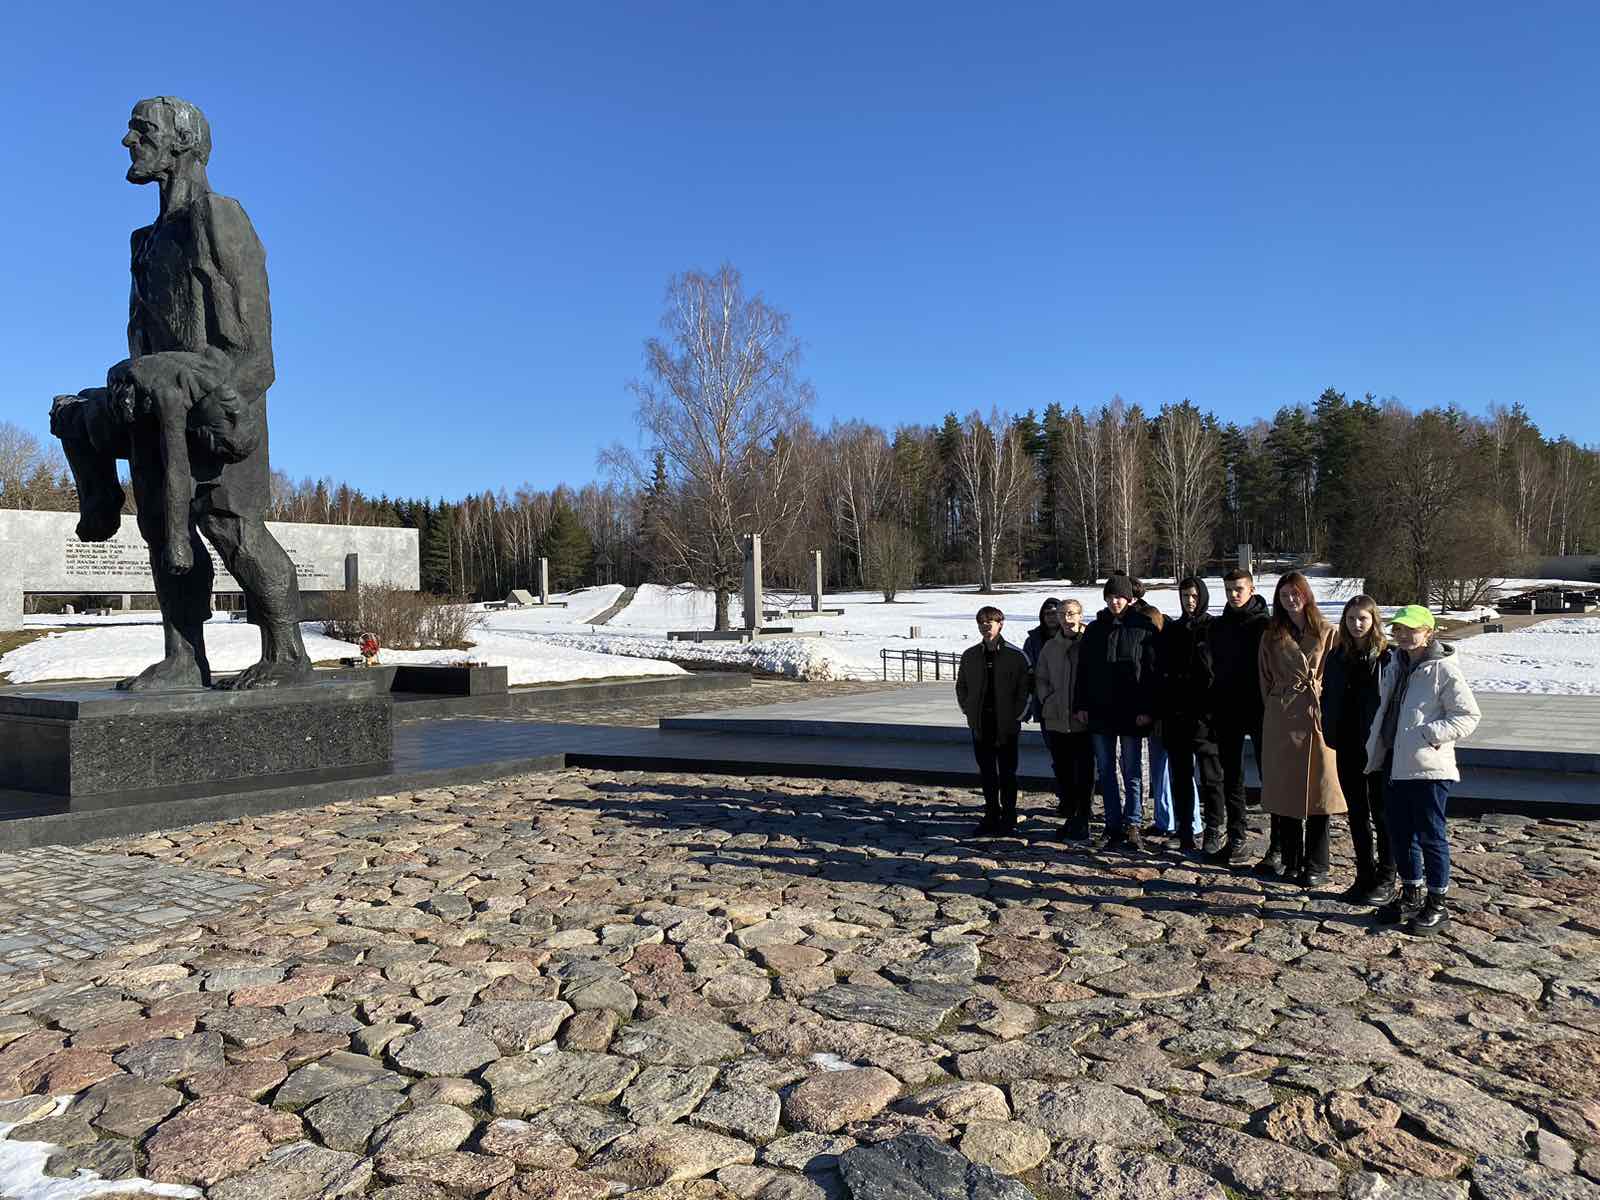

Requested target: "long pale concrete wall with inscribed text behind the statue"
[{"left": 0, "top": 509, "right": 421, "bottom": 594}]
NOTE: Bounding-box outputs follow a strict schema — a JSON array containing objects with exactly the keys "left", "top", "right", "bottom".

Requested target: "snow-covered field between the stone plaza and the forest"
[{"left": 0, "top": 574, "right": 1600, "bottom": 694}]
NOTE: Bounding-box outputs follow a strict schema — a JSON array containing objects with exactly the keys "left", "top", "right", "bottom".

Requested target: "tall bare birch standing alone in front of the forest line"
[{"left": 602, "top": 264, "right": 813, "bottom": 629}]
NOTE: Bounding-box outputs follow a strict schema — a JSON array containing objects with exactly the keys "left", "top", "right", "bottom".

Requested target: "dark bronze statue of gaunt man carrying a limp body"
[{"left": 51, "top": 96, "right": 310, "bottom": 690}]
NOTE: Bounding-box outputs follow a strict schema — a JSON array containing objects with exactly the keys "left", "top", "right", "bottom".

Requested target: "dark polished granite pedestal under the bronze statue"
[{"left": 0, "top": 678, "right": 394, "bottom": 810}]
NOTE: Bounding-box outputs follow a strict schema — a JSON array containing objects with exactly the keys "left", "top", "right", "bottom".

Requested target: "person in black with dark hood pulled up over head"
[{"left": 1160, "top": 576, "right": 1224, "bottom": 854}]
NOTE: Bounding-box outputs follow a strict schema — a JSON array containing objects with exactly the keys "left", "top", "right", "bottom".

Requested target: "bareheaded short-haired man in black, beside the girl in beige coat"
[{"left": 1206, "top": 570, "right": 1278, "bottom": 866}]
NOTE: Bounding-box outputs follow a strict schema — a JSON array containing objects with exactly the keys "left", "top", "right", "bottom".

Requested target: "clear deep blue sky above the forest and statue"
[{"left": 0, "top": 0, "right": 1600, "bottom": 496}]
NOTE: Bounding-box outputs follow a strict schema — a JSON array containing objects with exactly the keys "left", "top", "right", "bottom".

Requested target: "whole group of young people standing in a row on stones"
[{"left": 955, "top": 570, "right": 1478, "bottom": 934}]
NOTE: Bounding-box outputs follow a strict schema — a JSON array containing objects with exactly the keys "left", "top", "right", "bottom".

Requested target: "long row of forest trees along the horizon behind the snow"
[{"left": 0, "top": 389, "right": 1600, "bottom": 598}]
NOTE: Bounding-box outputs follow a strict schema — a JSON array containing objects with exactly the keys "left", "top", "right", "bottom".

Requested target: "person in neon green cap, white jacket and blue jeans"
[{"left": 1366, "top": 605, "right": 1480, "bottom": 934}]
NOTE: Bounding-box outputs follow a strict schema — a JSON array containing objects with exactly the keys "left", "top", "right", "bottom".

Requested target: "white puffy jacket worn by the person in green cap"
[{"left": 1366, "top": 642, "right": 1482, "bottom": 781}]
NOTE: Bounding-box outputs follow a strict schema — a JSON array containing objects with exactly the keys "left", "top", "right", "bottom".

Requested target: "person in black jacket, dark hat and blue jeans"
[{"left": 1072, "top": 574, "right": 1160, "bottom": 850}]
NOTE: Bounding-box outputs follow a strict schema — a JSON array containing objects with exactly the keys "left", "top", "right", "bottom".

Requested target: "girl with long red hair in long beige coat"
[{"left": 1256, "top": 571, "right": 1346, "bottom": 888}]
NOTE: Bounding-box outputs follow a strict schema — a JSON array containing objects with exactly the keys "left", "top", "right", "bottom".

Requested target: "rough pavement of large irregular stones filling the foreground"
[{"left": 0, "top": 771, "right": 1600, "bottom": 1200}]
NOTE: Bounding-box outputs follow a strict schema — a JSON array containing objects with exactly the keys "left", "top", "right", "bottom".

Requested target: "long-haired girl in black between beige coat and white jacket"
[{"left": 1322, "top": 595, "right": 1398, "bottom": 904}]
